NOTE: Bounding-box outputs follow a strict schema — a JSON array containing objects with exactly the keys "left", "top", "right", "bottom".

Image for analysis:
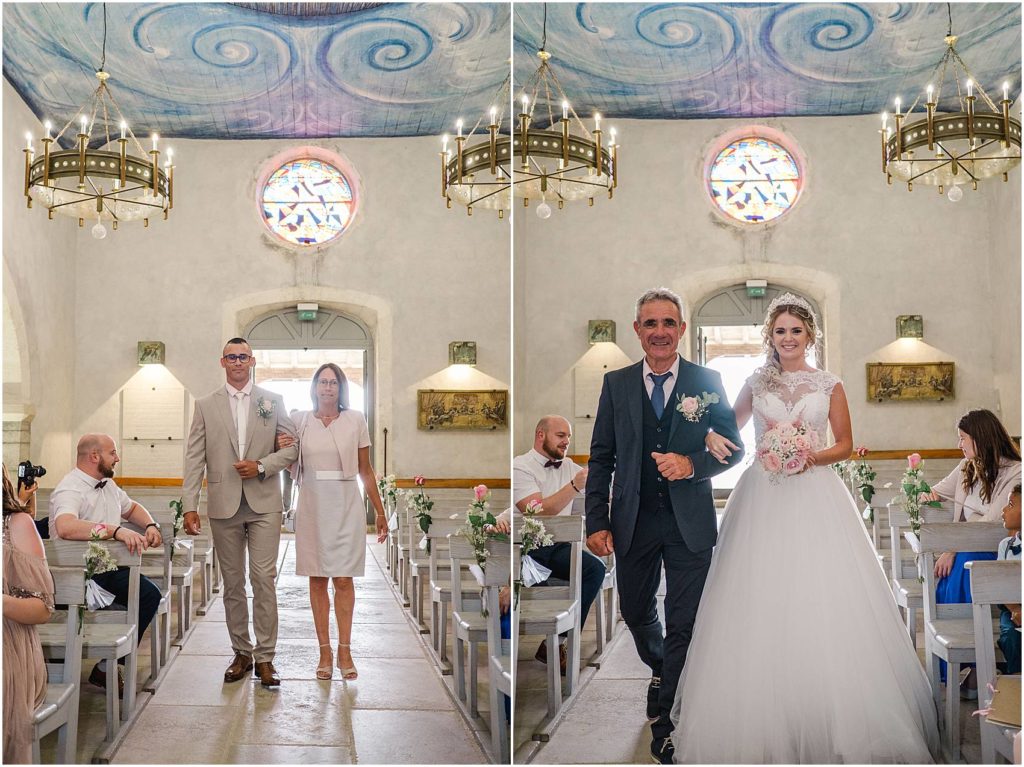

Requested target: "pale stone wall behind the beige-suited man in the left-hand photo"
[{"left": 4, "top": 83, "right": 511, "bottom": 481}]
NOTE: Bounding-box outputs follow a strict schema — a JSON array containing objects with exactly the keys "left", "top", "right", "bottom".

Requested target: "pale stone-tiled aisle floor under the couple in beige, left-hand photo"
[{"left": 114, "top": 536, "right": 486, "bottom": 764}]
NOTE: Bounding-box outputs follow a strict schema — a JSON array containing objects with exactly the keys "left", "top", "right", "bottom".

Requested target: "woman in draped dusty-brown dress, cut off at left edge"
[{"left": 3, "top": 466, "right": 53, "bottom": 764}]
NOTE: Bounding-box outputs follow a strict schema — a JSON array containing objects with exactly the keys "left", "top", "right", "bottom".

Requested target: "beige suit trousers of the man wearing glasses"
[{"left": 210, "top": 493, "right": 281, "bottom": 663}]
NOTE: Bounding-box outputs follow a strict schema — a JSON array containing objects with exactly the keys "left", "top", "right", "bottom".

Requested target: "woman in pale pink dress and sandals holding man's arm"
[{"left": 284, "top": 363, "right": 387, "bottom": 680}]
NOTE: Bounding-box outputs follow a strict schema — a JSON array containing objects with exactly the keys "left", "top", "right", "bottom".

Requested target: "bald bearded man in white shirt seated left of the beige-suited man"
[{"left": 50, "top": 434, "right": 164, "bottom": 694}]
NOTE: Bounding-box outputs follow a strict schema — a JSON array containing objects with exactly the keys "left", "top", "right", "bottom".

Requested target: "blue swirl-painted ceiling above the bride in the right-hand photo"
[{"left": 513, "top": 2, "right": 1021, "bottom": 119}]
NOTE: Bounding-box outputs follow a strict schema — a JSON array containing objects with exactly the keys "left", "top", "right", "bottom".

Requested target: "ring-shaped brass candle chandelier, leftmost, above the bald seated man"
[{"left": 24, "top": 3, "right": 174, "bottom": 240}]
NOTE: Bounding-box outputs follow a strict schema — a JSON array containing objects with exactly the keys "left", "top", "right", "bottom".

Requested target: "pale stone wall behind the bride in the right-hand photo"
[{"left": 513, "top": 110, "right": 1021, "bottom": 454}]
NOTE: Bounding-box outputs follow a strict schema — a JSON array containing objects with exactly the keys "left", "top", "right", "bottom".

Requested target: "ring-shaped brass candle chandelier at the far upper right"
[{"left": 880, "top": 3, "right": 1021, "bottom": 202}]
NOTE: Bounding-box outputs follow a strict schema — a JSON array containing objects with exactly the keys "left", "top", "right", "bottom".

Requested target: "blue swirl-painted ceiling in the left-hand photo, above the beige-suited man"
[{"left": 3, "top": 2, "right": 511, "bottom": 138}]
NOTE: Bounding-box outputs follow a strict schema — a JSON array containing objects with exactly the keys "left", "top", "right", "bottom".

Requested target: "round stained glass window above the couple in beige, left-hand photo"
[{"left": 262, "top": 158, "right": 354, "bottom": 245}]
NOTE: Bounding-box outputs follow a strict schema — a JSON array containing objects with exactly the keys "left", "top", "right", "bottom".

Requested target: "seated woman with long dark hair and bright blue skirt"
[{"left": 925, "top": 410, "right": 1021, "bottom": 699}]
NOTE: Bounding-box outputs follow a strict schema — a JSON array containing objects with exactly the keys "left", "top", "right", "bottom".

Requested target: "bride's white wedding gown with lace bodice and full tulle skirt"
[{"left": 672, "top": 371, "right": 939, "bottom": 764}]
